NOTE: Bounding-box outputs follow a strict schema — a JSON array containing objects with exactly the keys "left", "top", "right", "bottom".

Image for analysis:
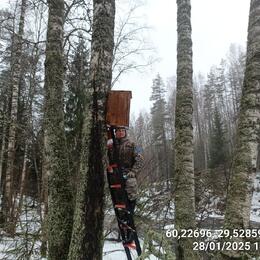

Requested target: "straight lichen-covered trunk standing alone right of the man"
[{"left": 174, "top": 0, "right": 199, "bottom": 260}]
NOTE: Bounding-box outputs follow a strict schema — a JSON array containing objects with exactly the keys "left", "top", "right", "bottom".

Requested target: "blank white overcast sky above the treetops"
[{"left": 0, "top": 0, "right": 250, "bottom": 114}]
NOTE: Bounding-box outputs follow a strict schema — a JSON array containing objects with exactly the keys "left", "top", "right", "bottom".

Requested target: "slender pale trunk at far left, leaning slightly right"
[{"left": 3, "top": 0, "right": 27, "bottom": 225}]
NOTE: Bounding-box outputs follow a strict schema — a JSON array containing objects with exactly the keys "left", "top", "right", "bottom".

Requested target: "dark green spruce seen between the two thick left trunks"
[{"left": 65, "top": 35, "right": 90, "bottom": 189}]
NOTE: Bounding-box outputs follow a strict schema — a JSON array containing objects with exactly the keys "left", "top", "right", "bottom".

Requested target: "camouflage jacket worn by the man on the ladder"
[{"left": 108, "top": 138, "right": 144, "bottom": 174}]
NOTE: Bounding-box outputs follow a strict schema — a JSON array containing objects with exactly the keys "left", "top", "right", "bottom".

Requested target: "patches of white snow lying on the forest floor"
[{"left": 0, "top": 173, "right": 260, "bottom": 260}]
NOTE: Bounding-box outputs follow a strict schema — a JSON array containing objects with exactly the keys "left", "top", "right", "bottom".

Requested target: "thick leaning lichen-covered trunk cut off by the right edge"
[{"left": 220, "top": 0, "right": 260, "bottom": 257}]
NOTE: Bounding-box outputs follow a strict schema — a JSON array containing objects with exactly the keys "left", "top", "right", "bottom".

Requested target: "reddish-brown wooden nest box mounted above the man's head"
[{"left": 106, "top": 90, "right": 132, "bottom": 127}]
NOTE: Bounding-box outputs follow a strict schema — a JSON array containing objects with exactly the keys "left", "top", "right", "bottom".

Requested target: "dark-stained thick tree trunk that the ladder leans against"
[{"left": 69, "top": 0, "right": 115, "bottom": 260}]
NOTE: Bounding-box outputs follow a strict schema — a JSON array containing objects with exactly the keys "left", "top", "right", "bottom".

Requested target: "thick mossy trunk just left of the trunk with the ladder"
[{"left": 44, "top": 0, "right": 73, "bottom": 260}]
